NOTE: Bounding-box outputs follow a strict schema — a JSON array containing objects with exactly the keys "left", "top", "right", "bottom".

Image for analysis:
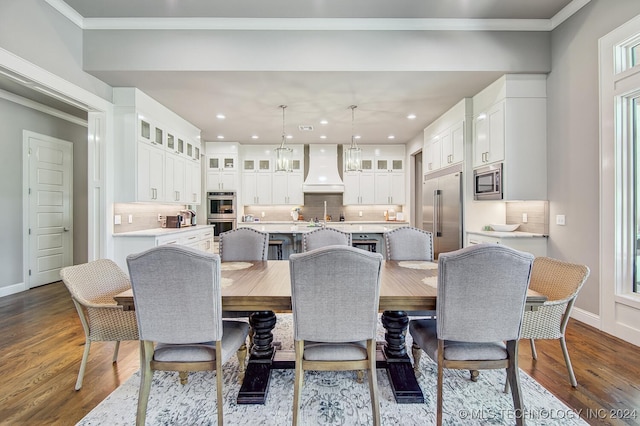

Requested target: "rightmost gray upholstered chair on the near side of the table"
[{"left": 409, "top": 244, "right": 533, "bottom": 425}]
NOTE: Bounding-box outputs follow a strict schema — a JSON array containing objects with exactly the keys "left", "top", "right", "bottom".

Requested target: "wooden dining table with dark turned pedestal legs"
[{"left": 114, "top": 260, "right": 546, "bottom": 404}]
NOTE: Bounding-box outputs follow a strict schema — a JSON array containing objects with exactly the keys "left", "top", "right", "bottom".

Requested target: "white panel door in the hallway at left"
[{"left": 27, "top": 133, "right": 73, "bottom": 287}]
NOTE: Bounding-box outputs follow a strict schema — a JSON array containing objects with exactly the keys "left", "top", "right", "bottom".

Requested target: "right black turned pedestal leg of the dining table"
[{"left": 382, "top": 311, "right": 424, "bottom": 404}]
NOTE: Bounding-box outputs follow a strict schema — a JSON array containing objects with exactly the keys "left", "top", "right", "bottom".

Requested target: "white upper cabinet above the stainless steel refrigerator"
[{"left": 423, "top": 99, "right": 471, "bottom": 174}]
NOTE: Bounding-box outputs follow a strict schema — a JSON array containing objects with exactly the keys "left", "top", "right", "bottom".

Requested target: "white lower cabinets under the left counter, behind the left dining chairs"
[{"left": 113, "top": 225, "right": 214, "bottom": 272}]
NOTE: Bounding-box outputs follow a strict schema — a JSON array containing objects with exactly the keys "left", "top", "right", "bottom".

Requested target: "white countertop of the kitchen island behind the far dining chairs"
[{"left": 238, "top": 221, "right": 409, "bottom": 234}]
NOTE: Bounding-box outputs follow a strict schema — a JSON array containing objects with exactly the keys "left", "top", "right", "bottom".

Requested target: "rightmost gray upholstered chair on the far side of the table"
[{"left": 384, "top": 226, "right": 435, "bottom": 317}]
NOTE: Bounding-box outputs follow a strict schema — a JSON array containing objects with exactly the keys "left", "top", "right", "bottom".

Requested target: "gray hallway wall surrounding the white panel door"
[{"left": 0, "top": 98, "right": 88, "bottom": 287}]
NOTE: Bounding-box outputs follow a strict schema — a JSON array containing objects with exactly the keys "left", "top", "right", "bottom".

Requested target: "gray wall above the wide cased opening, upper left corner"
[{"left": 0, "top": 0, "right": 111, "bottom": 100}]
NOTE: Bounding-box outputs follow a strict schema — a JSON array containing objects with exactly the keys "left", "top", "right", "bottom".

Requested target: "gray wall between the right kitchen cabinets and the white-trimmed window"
[{"left": 547, "top": 0, "right": 640, "bottom": 314}]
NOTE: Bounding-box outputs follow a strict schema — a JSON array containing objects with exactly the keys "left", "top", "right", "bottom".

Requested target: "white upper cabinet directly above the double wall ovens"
[{"left": 206, "top": 142, "right": 240, "bottom": 191}]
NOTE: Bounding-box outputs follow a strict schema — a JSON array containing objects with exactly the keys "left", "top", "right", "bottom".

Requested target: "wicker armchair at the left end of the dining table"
[{"left": 60, "top": 259, "right": 138, "bottom": 390}]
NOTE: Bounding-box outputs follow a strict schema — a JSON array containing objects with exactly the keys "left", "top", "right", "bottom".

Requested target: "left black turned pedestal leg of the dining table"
[{"left": 237, "top": 311, "right": 276, "bottom": 404}]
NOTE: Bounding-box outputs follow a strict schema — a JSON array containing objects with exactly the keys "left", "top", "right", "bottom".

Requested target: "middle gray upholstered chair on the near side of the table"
[{"left": 289, "top": 246, "right": 382, "bottom": 425}]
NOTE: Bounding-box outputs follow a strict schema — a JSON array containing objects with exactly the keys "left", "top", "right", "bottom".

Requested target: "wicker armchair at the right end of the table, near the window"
[{"left": 520, "top": 257, "right": 589, "bottom": 387}]
